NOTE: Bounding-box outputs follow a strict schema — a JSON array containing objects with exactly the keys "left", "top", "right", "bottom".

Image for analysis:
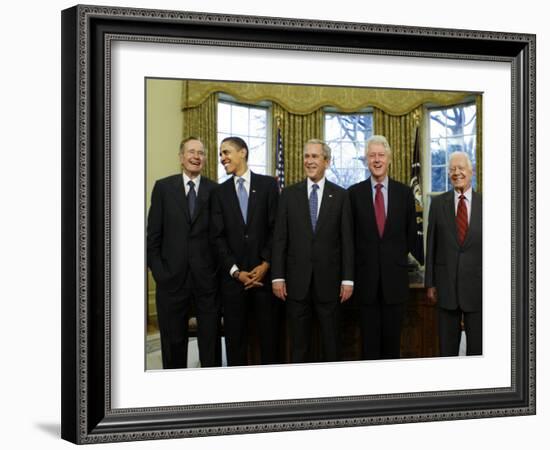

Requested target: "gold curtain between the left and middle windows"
[{"left": 271, "top": 103, "right": 324, "bottom": 186}]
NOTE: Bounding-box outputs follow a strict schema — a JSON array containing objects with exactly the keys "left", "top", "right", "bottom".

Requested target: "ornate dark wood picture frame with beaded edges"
[{"left": 62, "top": 6, "right": 535, "bottom": 444}]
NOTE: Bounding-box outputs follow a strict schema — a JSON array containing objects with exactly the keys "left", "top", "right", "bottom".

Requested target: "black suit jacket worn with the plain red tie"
[{"left": 349, "top": 178, "right": 416, "bottom": 304}]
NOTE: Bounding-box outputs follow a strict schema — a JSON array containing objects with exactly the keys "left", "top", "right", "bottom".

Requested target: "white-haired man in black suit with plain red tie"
[{"left": 349, "top": 135, "right": 416, "bottom": 359}]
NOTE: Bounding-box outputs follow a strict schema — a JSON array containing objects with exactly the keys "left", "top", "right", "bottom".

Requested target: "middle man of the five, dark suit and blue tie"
[{"left": 272, "top": 139, "right": 353, "bottom": 363}]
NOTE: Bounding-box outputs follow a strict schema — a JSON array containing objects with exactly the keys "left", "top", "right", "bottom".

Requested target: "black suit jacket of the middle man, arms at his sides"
[{"left": 271, "top": 180, "right": 353, "bottom": 302}]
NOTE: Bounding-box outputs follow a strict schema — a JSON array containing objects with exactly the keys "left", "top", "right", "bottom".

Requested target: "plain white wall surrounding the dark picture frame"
[{"left": 0, "top": 0, "right": 550, "bottom": 450}]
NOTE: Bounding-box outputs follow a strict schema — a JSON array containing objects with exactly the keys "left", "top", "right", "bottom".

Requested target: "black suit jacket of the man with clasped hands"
[{"left": 211, "top": 172, "right": 279, "bottom": 291}]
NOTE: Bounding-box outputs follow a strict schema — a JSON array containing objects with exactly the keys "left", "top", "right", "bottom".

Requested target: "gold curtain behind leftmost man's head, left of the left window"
[{"left": 183, "top": 93, "right": 218, "bottom": 180}]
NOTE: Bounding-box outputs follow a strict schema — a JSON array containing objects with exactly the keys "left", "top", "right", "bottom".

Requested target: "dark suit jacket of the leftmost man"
[{"left": 147, "top": 174, "right": 217, "bottom": 289}]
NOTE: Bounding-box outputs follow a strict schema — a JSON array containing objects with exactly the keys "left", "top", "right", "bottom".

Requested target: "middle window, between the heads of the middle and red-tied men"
[{"left": 325, "top": 112, "right": 373, "bottom": 188}]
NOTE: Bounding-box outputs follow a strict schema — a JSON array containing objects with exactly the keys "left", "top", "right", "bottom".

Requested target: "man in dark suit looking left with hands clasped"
[{"left": 212, "top": 137, "right": 280, "bottom": 366}]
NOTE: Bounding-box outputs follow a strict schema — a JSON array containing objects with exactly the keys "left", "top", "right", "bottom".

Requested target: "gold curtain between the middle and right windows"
[{"left": 373, "top": 106, "right": 423, "bottom": 184}]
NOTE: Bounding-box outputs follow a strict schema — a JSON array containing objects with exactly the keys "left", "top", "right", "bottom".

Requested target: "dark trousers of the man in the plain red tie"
[{"left": 359, "top": 285, "right": 405, "bottom": 359}]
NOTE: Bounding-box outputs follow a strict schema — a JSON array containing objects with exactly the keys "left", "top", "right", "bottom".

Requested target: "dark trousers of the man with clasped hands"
[{"left": 222, "top": 281, "right": 281, "bottom": 366}]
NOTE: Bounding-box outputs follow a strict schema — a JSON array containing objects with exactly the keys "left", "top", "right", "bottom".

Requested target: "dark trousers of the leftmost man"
[{"left": 156, "top": 271, "right": 220, "bottom": 369}]
